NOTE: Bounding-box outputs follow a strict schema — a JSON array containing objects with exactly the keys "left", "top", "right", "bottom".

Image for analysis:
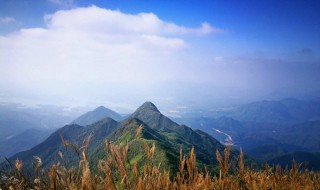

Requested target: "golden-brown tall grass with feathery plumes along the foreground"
[{"left": 0, "top": 129, "right": 320, "bottom": 190}]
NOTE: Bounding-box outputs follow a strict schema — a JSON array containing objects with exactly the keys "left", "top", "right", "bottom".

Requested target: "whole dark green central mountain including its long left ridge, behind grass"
[{"left": 10, "top": 102, "right": 246, "bottom": 174}]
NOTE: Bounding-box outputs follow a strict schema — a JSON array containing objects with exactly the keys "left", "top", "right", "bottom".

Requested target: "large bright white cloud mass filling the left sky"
[{"left": 0, "top": 5, "right": 217, "bottom": 107}]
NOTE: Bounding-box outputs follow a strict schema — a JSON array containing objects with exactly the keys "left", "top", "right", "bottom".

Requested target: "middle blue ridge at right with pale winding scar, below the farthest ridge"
[{"left": 178, "top": 117, "right": 320, "bottom": 151}]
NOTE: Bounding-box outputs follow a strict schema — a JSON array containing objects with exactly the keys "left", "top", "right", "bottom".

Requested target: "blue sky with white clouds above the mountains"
[{"left": 0, "top": 0, "right": 320, "bottom": 110}]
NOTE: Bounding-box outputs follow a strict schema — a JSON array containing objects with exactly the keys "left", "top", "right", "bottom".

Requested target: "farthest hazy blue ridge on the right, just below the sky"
[{"left": 204, "top": 99, "right": 320, "bottom": 124}]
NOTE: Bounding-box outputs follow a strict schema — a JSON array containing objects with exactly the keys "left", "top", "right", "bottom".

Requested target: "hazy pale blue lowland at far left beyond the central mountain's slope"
[{"left": 0, "top": 103, "right": 89, "bottom": 157}]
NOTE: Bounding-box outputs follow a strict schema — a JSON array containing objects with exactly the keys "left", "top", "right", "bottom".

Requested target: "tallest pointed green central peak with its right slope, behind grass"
[{"left": 92, "top": 102, "right": 249, "bottom": 173}]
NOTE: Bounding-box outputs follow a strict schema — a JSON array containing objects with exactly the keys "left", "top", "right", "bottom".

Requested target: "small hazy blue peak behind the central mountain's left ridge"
[{"left": 71, "top": 106, "right": 122, "bottom": 126}]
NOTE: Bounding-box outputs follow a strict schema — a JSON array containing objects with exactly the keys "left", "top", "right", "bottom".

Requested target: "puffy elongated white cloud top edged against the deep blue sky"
[{"left": 45, "top": 6, "right": 223, "bottom": 35}]
